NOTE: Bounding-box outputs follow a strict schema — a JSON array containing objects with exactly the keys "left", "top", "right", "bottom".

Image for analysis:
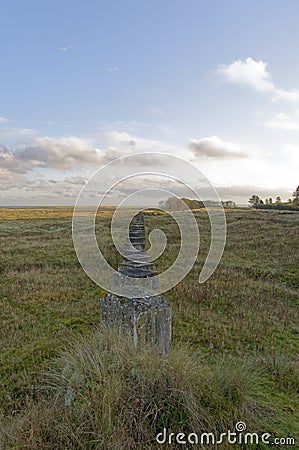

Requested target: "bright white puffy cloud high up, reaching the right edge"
[{"left": 217, "top": 57, "right": 299, "bottom": 102}]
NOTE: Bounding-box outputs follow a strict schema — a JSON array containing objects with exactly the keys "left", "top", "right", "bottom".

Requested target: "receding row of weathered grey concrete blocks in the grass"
[{"left": 100, "top": 213, "right": 172, "bottom": 353}]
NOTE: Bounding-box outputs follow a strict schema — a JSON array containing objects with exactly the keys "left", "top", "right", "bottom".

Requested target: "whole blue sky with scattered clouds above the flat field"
[{"left": 0, "top": 0, "right": 299, "bottom": 205}]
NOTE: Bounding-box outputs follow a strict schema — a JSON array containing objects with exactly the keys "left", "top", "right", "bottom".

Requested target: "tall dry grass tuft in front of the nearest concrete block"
[{"left": 1, "top": 329, "right": 270, "bottom": 450}]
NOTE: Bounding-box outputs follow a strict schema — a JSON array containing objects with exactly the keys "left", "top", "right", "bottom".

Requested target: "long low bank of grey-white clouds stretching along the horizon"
[{"left": 0, "top": 128, "right": 299, "bottom": 204}]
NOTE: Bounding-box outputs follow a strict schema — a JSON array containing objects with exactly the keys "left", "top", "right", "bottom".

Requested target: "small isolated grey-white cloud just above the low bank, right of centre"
[{"left": 189, "top": 136, "right": 247, "bottom": 159}]
